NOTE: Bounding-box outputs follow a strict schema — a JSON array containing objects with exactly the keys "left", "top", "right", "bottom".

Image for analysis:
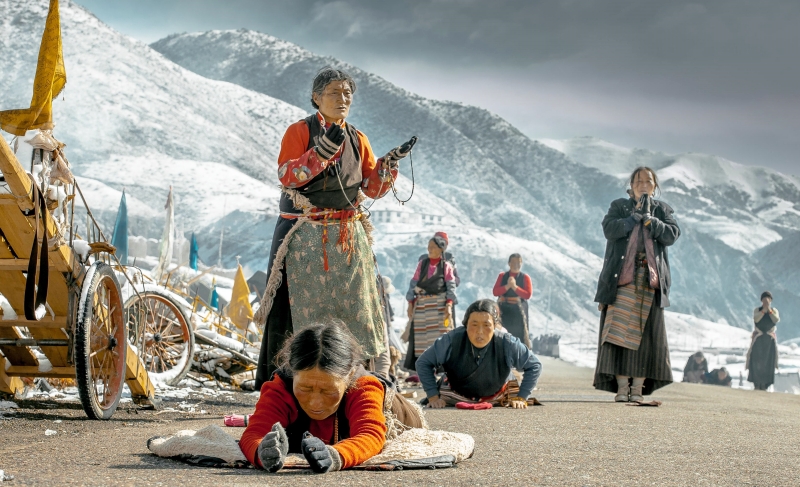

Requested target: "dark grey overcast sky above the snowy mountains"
[{"left": 77, "top": 0, "right": 800, "bottom": 174}]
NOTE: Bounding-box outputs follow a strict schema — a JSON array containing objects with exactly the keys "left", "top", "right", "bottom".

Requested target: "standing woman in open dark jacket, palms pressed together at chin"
[{"left": 594, "top": 167, "right": 680, "bottom": 402}]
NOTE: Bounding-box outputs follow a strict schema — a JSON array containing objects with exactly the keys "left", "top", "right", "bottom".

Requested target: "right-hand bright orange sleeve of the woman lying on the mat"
[{"left": 333, "top": 376, "right": 386, "bottom": 469}]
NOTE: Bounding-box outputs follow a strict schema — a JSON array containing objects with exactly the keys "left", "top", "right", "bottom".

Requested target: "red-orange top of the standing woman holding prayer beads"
[{"left": 278, "top": 112, "right": 397, "bottom": 199}]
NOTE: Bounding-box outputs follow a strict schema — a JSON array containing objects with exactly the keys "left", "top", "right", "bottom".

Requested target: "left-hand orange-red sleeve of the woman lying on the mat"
[{"left": 239, "top": 375, "right": 297, "bottom": 467}]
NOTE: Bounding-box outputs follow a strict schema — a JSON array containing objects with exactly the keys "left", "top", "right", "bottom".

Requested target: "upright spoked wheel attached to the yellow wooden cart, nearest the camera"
[{"left": 75, "top": 262, "right": 128, "bottom": 419}]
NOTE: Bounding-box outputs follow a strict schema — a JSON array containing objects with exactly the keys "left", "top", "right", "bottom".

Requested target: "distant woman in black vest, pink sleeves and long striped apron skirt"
[{"left": 403, "top": 232, "right": 457, "bottom": 370}]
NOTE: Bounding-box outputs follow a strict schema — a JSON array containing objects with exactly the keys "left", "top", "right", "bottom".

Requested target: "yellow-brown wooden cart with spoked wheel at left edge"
[{"left": 0, "top": 137, "right": 155, "bottom": 419}]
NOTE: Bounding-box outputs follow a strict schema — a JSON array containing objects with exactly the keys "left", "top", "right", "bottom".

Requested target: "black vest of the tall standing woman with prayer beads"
[{"left": 281, "top": 113, "right": 363, "bottom": 213}]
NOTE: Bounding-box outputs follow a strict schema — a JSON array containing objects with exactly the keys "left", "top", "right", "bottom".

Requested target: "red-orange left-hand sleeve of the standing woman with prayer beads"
[{"left": 278, "top": 120, "right": 326, "bottom": 188}]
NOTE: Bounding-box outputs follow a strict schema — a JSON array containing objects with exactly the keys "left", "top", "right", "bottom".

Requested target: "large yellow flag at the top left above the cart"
[{"left": 0, "top": 0, "right": 67, "bottom": 136}]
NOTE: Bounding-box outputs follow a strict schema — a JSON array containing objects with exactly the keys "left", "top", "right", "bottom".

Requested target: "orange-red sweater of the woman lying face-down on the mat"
[{"left": 239, "top": 374, "right": 386, "bottom": 468}]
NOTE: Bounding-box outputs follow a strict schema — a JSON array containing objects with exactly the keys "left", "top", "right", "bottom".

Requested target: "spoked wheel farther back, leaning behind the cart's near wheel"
[{"left": 125, "top": 286, "right": 194, "bottom": 386}]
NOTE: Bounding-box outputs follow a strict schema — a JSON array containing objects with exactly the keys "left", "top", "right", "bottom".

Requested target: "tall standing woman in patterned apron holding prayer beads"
[{"left": 255, "top": 68, "right": 415, "bottom": 388}]
